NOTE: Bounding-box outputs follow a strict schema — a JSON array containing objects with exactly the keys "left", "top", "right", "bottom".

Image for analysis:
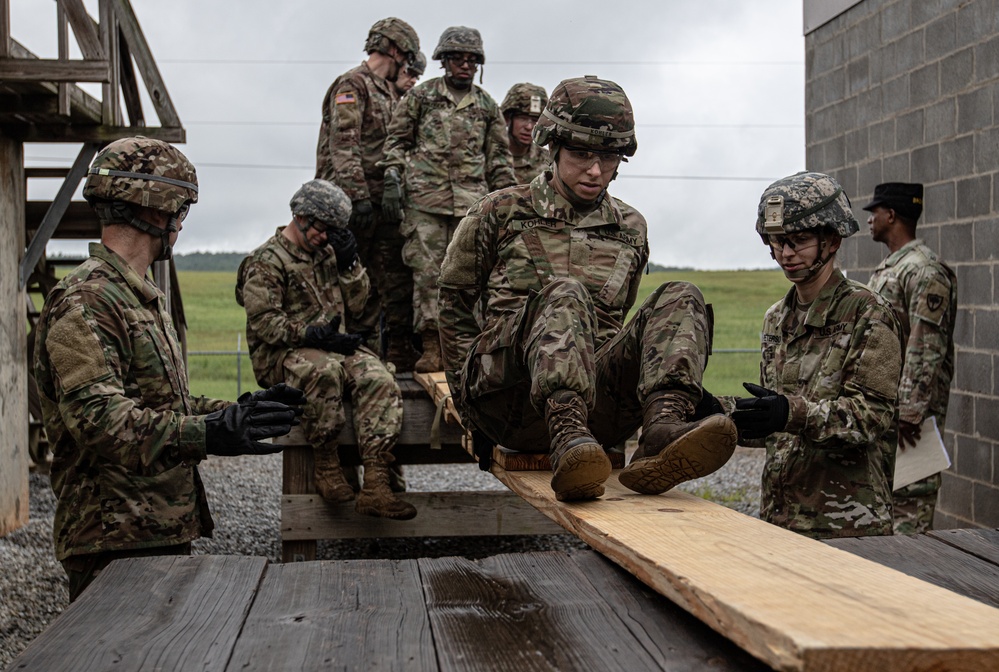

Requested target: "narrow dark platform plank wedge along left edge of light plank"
[{"left": 568, "top": 551, "right": 772, "bottom": 672}]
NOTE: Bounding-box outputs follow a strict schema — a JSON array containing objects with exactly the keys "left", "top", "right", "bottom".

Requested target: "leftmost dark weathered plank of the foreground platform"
[{"left": 10, "top": 555, "right": 267, "bottom": 672}]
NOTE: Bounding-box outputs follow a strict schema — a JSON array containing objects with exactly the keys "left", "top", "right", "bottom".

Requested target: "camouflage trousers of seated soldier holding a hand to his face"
[{"left": 283, "top": 348, "right": 402, "bottom": 459}]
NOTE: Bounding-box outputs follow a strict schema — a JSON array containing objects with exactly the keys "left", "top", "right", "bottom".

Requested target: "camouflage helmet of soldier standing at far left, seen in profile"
[{"left": 83, "top": 135, "right": 198, "bottom": 215}]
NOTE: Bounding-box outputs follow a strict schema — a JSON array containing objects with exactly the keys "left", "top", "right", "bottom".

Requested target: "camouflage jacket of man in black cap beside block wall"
[{"left": 869, "top": 239, "right": 957, "bottom": 425}]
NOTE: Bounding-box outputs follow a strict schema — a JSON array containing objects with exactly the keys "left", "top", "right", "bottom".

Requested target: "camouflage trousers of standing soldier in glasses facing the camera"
[{"left": 402, "top": 208, "right": 461, "bottom": 333}]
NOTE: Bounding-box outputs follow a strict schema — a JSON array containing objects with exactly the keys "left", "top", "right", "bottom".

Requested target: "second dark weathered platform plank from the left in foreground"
[{"left": 232, "top": 560, "right": 438, "bottom": 672}]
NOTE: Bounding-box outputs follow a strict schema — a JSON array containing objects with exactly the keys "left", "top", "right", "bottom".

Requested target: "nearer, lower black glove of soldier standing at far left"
[{"left": 205, "top": 400, "right": 298, "bottom": 457}]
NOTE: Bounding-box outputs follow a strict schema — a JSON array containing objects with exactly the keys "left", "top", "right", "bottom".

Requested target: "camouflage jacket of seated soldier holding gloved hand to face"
[{"left": 236, "top": 226, "right": 370, "bottom": 387}]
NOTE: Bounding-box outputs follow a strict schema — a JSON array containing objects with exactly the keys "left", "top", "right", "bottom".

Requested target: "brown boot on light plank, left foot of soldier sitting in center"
[{"left": 545, "top": 390, "right": 611, "bottom": 502}]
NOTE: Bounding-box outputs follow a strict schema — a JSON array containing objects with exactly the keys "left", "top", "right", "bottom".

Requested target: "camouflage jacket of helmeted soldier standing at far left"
[{"left": 35, "top": 243, "right": 229, "bottom": 560}]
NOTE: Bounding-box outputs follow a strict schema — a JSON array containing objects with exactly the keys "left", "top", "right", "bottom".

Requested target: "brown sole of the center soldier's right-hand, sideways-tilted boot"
[{"left": 617, "top": 415, "right": 738, "bottom": 495}]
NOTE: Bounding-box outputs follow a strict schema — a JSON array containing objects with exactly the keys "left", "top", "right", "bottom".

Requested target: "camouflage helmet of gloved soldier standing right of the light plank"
[{"left": 756, "top": 171, "right": 860, "bottom": 242}]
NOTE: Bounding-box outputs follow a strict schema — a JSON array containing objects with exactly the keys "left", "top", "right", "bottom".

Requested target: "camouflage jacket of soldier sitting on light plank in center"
[{"left": 438, "top": 172, "right": 649, "bottom": 391}]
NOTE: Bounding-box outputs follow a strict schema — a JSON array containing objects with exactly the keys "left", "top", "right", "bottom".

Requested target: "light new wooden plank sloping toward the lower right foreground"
[{"left": 493, "top": 467, "right": 999, "bottom": 672}]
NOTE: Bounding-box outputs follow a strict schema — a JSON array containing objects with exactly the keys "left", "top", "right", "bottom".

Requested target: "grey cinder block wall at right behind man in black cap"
[{"left": 805, "top": 0, "right": 999, "bottom": 528}]
